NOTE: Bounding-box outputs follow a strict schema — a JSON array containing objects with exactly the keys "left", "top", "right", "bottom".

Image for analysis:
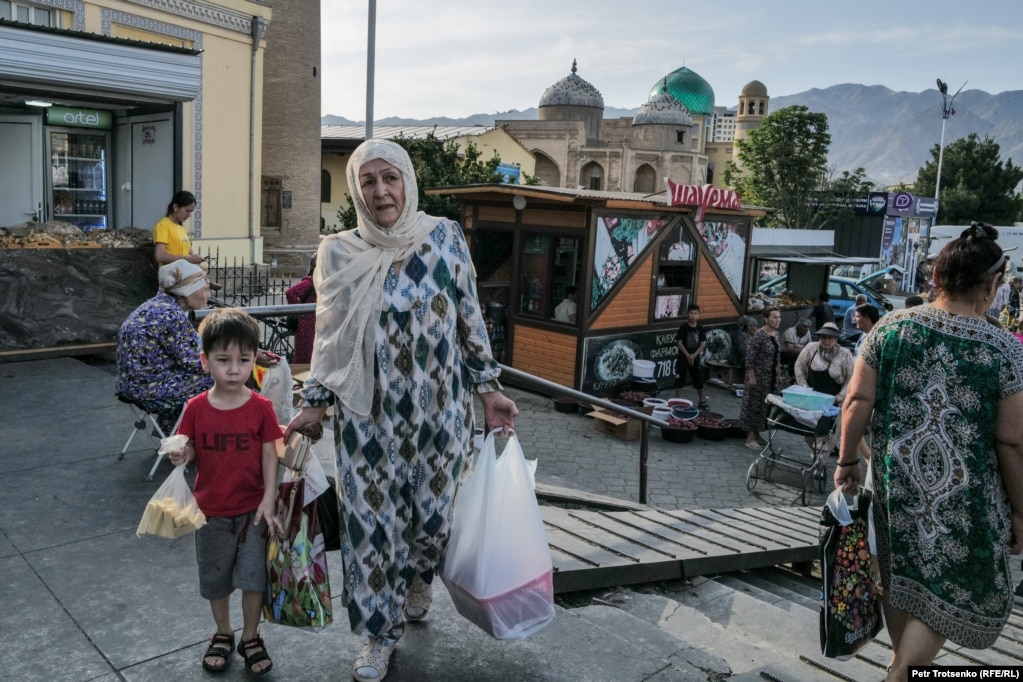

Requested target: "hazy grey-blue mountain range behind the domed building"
[{"left": 320, "top": 84, "right": 1023, "bottom": 186}]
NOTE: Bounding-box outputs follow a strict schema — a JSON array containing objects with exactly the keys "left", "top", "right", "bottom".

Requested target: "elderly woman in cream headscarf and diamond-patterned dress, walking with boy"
[{"left": 285, "top": 139, "right": 518, "bottom": 681}]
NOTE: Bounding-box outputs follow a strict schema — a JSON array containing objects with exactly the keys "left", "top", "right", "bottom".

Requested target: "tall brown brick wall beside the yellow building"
[{"left": 257, "top": 0, "right": 321, "bottom": 274}]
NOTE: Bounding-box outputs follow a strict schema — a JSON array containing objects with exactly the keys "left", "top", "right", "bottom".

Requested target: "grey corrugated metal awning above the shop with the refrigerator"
[{"left": 0, "top": 22, "right": 203, "bottom": 102}]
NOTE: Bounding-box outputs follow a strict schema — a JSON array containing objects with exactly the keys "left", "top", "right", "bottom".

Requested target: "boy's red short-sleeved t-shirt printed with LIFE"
[{"left": 178, "top": 392, "right": 284, "bottom": 516}]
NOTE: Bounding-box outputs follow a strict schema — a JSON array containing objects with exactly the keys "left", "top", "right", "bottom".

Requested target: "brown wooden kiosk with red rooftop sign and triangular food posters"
[{"left": 430, "top": 185, "right": 766, "bottom": 395}]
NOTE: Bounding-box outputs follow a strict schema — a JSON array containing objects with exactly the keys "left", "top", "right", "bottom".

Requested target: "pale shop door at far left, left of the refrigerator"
[{"left": 0, "top": 117, "right": 44, "bottom": 226}]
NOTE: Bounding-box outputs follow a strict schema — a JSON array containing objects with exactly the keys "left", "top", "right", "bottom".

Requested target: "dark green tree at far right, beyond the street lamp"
[{"left": 915, "top": 133, "right": 1023, "bottom": 225}]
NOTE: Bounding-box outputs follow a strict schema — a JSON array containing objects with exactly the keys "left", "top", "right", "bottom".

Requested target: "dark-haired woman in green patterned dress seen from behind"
[{"left": 835, "top": 224, "right": 1023, "bottom": 680}]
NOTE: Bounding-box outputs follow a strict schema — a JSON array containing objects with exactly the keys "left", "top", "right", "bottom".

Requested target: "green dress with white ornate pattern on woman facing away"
[{"left": 861, "top": 306, "right": 1023, "bottom": 648}]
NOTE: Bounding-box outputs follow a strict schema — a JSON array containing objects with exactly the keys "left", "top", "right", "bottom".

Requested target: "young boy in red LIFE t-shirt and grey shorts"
[{"left": 169, "top": 309, "right": 283, "bottom": 675}]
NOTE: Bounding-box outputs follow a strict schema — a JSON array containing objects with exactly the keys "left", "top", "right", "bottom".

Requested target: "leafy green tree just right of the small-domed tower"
[{"left": 724, "top": 105, "right": 834, "bottom": 228}]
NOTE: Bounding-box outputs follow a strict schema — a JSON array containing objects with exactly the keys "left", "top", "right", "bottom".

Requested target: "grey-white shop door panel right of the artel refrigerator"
[{"left": 131, "top": 116, "right": 171, "bottom": 229}]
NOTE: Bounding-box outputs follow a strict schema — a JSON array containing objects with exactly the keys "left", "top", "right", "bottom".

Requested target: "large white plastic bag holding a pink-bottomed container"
[{"left": 441, "top": 431, "right": 554, "bottom": 639}]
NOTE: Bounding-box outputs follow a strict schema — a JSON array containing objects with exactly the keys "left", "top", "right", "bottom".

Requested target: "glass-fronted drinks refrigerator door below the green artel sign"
[{"left": 46, "top": 128, "right": 110, "bottom": 232}]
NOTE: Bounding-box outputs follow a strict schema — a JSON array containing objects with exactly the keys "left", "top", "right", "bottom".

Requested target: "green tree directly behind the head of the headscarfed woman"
[{"left": 338, "top": 132, "right": 504, "bottom": 231}]
